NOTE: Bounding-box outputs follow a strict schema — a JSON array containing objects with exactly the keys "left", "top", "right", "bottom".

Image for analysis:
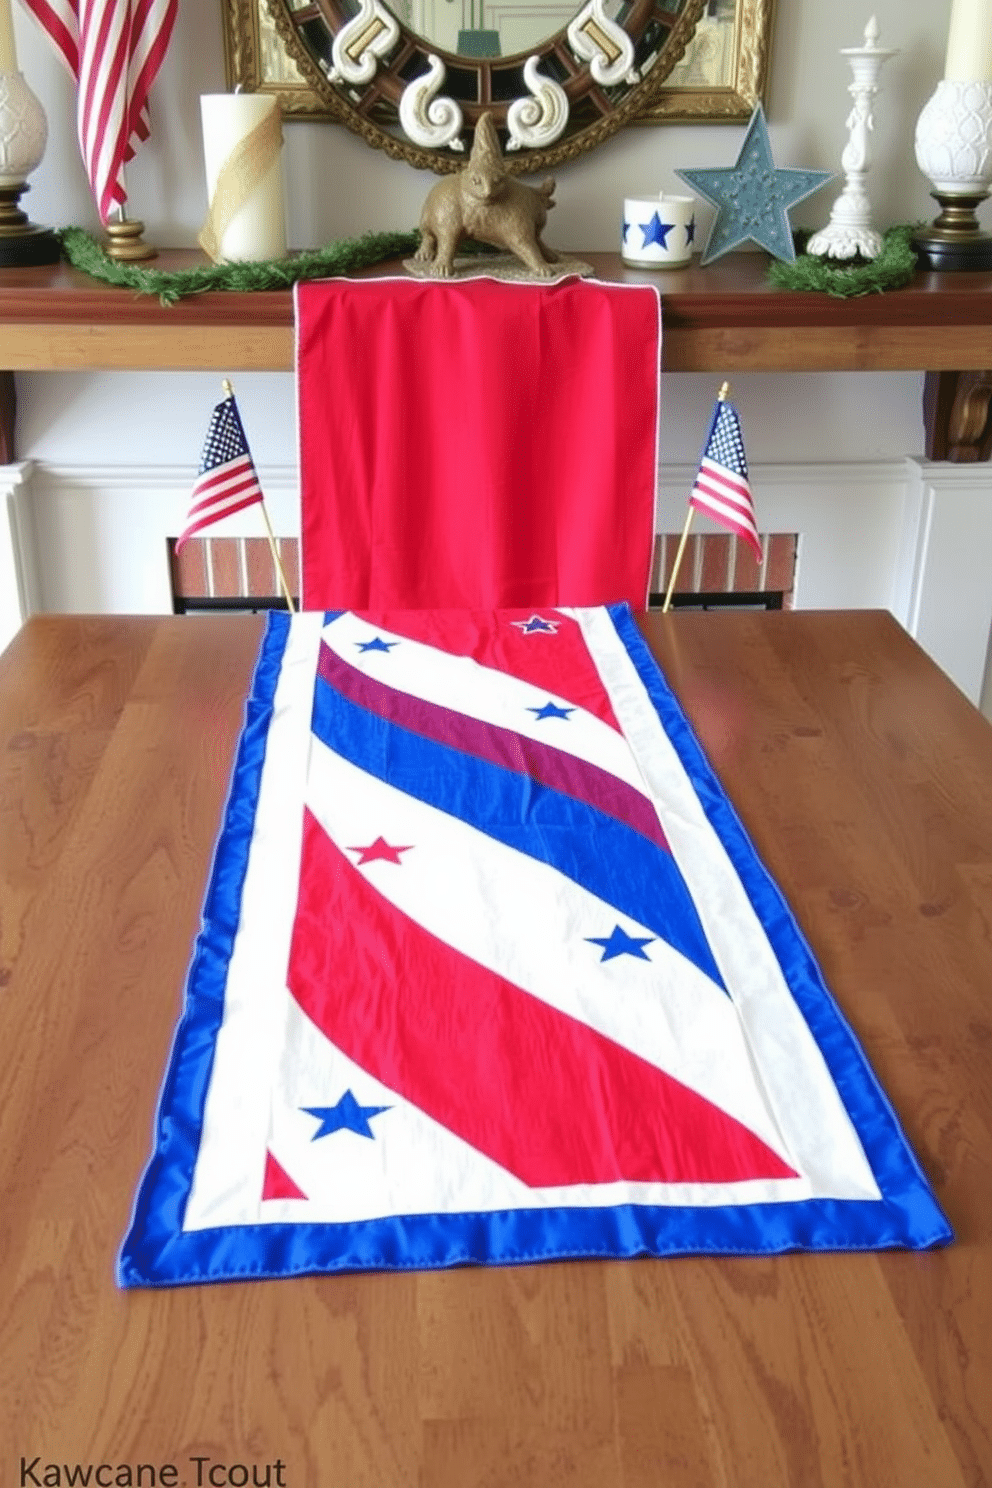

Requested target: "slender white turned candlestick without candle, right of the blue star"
[{"left": 806, "top": 16, "right": 895, "bottom": 259}]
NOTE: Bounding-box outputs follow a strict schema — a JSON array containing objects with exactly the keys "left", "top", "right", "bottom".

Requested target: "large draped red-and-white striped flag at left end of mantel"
[{"left": 24, "top": 0, "right": 178, "bottom": 223}]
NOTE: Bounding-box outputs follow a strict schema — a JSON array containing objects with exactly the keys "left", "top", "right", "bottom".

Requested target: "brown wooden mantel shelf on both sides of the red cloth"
[{"left": 0, "top": 250, "right": 992, "bottom": 461}]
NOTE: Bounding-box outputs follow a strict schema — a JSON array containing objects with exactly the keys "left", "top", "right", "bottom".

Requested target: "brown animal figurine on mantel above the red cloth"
[{"left": 413, "top": 113, "right": 558, "bottom": 278}]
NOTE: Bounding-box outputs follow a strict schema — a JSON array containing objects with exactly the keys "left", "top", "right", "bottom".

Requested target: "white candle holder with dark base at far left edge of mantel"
[{"left": 0, "top": 0, "right": 61, "bottom": 268}]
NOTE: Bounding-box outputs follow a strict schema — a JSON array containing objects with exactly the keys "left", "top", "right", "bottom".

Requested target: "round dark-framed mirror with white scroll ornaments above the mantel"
[{"left": 266, "top": 0, "right": 708, "bottom": 173}]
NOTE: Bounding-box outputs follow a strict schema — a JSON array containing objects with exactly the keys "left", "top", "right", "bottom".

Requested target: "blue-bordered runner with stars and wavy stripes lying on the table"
[{"left": 119, "top": 606, "right": 952, "bottom": 1287}]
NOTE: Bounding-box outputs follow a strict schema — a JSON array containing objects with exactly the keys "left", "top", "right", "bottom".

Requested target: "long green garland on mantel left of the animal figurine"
[{"left": 59, "top": 228, "right": 419, "bottom": 305}]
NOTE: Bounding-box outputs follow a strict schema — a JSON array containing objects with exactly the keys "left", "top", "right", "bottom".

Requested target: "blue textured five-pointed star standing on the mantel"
[{"left": 675, "top": 104, "right": 834, "bottom": 265}]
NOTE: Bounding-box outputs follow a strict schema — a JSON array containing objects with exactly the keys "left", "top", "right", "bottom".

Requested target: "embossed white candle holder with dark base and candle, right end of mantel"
[{"left": 913, "top": 0, "right": 992, "bottom": 269}]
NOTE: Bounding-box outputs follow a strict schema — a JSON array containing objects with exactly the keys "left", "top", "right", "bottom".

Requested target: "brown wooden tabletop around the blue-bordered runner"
[{"left": 0, "top": 612, "right": 992, "bottom": 1488}]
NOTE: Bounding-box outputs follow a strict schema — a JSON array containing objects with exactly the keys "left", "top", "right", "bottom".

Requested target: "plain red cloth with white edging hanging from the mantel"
[{"left": 294, "top": 277, "right": 660, "bottom": 610}]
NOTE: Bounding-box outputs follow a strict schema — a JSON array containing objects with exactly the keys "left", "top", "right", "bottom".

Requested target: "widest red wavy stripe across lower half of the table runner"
[{"left": 289, "top": 812, "right": 796, "bottom": 1187}]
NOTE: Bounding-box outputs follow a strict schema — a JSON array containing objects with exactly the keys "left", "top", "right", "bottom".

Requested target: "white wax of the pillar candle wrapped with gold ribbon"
[{"left": 199, "top": 92, "right": 286, "bottom": 262}]
